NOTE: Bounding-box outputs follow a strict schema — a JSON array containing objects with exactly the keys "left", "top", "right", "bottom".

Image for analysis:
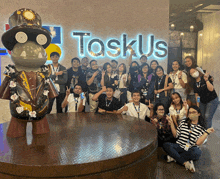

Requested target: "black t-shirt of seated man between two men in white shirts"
[{"left": 97, "top": 94, "right": 121, "bottom": 111}]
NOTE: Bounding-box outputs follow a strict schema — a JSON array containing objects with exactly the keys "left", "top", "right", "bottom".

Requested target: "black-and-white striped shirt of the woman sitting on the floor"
[{"left": 176, "top": 119, "right": 205, "bottom": 148}]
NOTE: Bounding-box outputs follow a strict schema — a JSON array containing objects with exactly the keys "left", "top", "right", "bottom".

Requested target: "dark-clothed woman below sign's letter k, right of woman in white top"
[{"left": 127, "top": 61, "right": 139, "bottom": 102}]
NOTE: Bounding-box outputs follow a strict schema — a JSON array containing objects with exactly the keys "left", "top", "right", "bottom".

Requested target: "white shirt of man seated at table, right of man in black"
[{"left": 122, "top": 102, "right": 150, "bottom": 120}]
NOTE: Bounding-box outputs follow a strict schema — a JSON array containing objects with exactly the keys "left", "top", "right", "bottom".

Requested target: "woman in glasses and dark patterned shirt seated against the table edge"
[{"left": 151, "top": 103, "right": 175, "bottom": 147}]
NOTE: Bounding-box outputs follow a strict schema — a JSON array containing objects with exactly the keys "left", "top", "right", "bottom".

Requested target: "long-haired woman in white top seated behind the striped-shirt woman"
[{"left": 169, "top": 92, "right": 189, "bottom": 127}]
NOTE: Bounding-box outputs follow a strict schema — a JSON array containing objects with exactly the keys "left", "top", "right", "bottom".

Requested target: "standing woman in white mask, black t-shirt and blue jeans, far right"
[{"left": 190, "top": 68, "right": 219, "bottom": 128}]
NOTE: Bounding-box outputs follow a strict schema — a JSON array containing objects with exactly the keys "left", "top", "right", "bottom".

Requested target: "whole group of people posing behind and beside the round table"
[{"left": 48, "top": 52, "right": 219, "bottom": 172}]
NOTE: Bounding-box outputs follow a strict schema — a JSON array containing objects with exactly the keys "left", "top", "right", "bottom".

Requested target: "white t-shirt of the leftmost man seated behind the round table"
[{"left": 67, "top": 93, "right": 86, "bottom": 112}]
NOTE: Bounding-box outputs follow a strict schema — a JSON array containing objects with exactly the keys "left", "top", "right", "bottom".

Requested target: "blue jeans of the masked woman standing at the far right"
[{"left": 199, "top": 97, "right": 219, "bottom": 129}]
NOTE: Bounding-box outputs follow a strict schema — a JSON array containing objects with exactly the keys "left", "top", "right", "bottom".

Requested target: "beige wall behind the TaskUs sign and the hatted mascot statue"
[{"left": 0, "top": 0, "right": 169, "bottom": 116}]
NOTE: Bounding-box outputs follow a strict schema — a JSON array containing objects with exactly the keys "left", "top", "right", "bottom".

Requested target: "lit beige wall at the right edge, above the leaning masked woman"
[{"left": 197, "top": 12, "right": 220, "bottom": 96}]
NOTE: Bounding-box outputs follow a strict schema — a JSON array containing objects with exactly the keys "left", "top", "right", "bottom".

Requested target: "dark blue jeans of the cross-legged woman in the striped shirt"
[{"left": 163, "top": 142, "right": 202, "bottom": 165}]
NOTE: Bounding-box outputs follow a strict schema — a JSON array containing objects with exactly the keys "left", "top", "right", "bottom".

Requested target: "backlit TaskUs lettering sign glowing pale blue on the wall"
[{"left": 72, "top": 32, "right": 168, "bottom": 60}]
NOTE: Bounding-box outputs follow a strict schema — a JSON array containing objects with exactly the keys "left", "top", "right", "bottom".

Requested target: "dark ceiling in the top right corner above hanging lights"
[{"left": 169, "top": 0, "right": 220, "bottom": 31}]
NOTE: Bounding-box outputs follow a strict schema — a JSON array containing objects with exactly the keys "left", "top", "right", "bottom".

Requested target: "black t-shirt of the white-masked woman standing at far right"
[{"left": 193, "top": 77, "right": 217, "bottom": 104}]
